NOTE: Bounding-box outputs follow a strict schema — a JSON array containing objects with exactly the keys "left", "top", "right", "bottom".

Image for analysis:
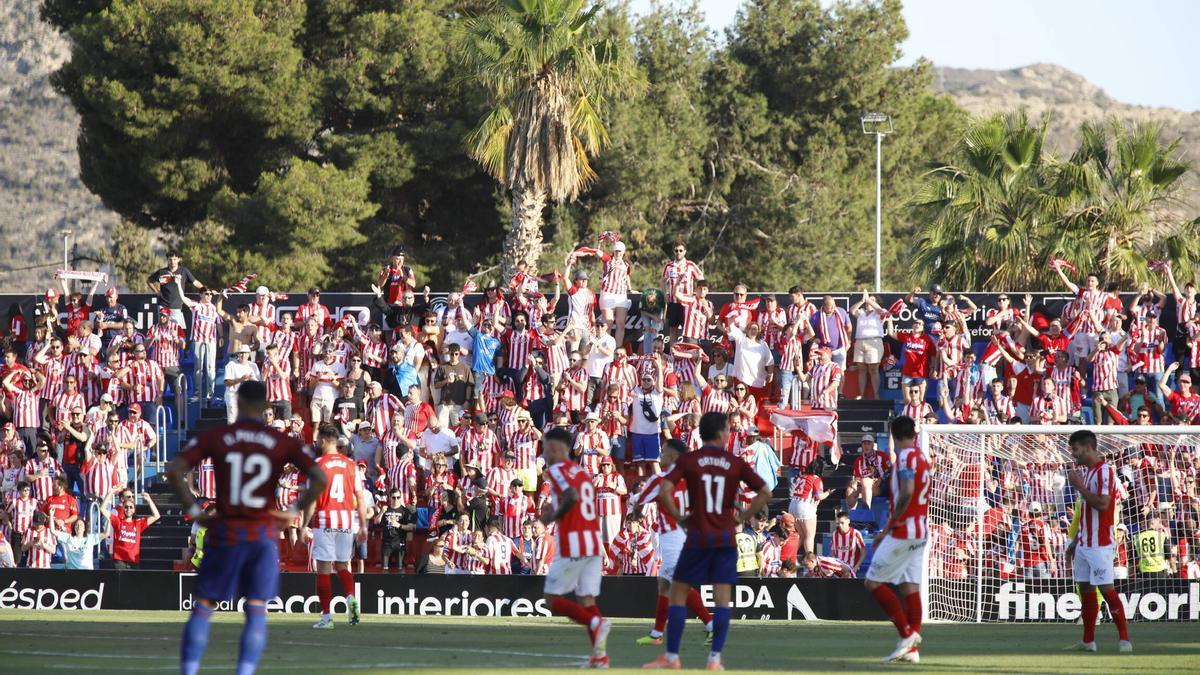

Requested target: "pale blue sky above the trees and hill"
[{"left": 632, "top": 0, "right": 1200, "bottom": 110}]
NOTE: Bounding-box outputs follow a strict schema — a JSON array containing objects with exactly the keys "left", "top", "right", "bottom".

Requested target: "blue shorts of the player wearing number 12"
[{"left": 192, "top": 539, "right": 280, "bottom": 602}]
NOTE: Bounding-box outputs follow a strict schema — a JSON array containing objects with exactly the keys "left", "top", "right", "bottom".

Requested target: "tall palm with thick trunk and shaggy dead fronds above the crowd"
[{"left": 458, "top": 0, "right": 643, "bottom": 279}]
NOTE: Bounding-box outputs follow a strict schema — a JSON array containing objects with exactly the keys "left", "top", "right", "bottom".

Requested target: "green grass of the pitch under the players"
[{"left": 0, "top": 610, "right": 1200, "bottom": 675}]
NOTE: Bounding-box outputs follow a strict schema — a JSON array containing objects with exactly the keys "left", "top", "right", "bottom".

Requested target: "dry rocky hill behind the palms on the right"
[{"left": 934, "top": 64, "right": 1200, "bottom": 208}]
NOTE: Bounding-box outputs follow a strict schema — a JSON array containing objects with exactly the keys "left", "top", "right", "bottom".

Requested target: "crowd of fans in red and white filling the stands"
[{"left": 0, "top": 243, "right": 1200, "bottom": 578}]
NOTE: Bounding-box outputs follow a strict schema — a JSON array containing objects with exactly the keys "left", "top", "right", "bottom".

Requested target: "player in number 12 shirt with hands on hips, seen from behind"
[{"left": 167, "top": 382, "right": 325, "bottom": 675}]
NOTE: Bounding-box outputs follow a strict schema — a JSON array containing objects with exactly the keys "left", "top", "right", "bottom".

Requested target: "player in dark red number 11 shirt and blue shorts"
[{"left": 646, "top": 412, "right": 770, "bottom": 670}]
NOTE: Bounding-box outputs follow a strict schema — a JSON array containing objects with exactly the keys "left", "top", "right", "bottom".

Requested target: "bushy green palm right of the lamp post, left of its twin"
[{"left": 912, "top": 110, "right": 1048, "bottom": 289}]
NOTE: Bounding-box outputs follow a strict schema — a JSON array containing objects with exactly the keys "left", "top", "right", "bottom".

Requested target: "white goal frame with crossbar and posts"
[{"left": 917, "top": 424, "right": 1200, "bottom": 623}]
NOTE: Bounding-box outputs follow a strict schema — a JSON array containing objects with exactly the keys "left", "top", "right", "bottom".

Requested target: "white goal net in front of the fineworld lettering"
[{"left": 919, "top": 425, "right": 1200, "bottom": 622}]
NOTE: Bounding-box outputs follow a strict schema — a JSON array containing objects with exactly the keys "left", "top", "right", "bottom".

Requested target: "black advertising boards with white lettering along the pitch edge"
[{"left": 0, "top": 569, "right": 1200, "bottom": 622}]
